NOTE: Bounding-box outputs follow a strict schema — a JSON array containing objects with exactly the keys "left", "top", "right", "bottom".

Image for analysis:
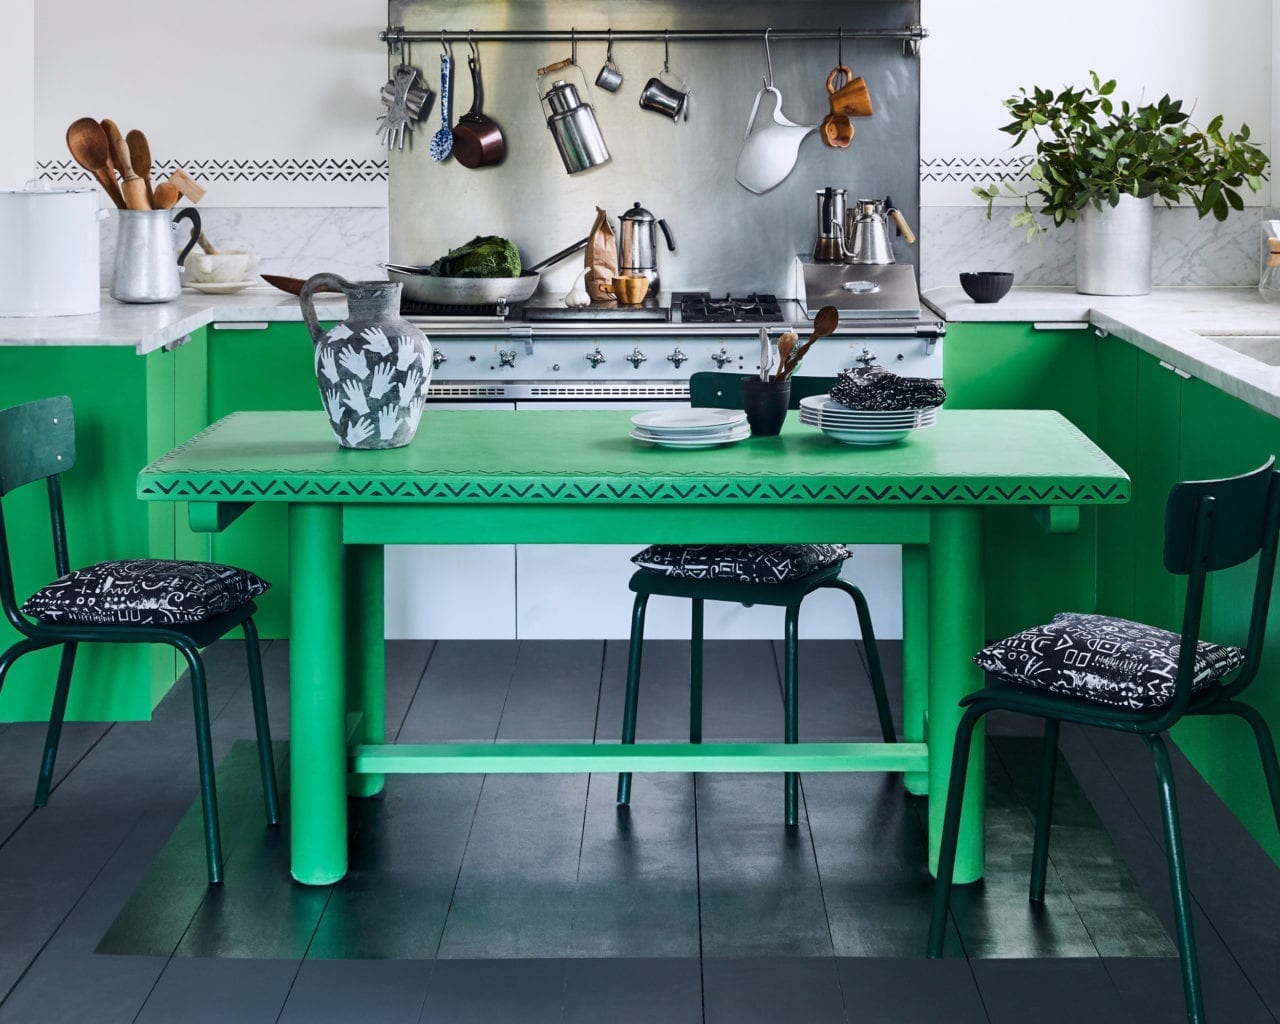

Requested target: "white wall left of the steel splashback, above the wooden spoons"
[{"left": 31, "top": 0, "right": 387, "bottom": 206}]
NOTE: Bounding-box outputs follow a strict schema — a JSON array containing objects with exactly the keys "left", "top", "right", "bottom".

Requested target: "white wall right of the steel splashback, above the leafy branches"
[{"left": 920, "top": 0, "right": 1280, "bottom": 206}]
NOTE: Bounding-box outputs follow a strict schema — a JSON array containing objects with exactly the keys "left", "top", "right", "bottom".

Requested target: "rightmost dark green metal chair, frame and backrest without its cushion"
[{"left": 927, "top": 458, "right": 1280, "bottom": 1023}]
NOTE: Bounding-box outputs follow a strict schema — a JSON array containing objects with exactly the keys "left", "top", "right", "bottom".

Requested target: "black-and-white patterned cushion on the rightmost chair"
[{"left": 973, "top": 612, "right": 1244, "bottom": 710}]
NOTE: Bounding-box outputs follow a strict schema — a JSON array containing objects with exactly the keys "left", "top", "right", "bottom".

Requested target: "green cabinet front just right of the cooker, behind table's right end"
[{"left": 943, "top": 324, "right": 1105, "bottom": 639}]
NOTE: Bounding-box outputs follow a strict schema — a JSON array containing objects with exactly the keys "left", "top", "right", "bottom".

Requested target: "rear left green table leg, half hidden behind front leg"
[{"left": 347, "top": 544, "right": 387, "bottom": 796}]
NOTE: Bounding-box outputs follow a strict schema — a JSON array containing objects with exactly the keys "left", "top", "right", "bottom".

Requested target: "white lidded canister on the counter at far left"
[{"left": 0, "top": 188, "right": 101, "bottom": 316}]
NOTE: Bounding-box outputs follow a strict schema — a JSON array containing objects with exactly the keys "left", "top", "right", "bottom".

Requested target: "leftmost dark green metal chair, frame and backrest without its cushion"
[{"left": 0, "top": 396, "right": 280, "bottom": 884}]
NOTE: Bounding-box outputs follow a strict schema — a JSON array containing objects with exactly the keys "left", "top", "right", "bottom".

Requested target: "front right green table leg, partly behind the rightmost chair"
[{"left": 925, "top": 508, "right": 986, "bottom": 884}]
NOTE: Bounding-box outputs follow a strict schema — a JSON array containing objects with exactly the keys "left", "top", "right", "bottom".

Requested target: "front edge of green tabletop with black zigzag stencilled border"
[{"left": 138, "top": 472, "right": 1129, "bottom": 506}]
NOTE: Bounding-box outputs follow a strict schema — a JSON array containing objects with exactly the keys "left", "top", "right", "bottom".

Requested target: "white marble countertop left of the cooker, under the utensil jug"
[{"left": 0, "top": 284, "right": 347, "bottom": 356}]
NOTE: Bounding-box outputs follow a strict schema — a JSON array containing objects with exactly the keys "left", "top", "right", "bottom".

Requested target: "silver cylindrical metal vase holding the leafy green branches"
[{"left": 1075, "top": 196, "right": 1152, "bottom": 296}]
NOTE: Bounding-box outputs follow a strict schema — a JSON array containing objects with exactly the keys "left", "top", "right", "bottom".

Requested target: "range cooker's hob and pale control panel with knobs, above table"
[{"left": 406, "top": 284, "right": 945, "bottom": 404}]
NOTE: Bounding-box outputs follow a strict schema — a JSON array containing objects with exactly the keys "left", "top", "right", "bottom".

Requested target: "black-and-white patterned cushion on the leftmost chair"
[{"left": 22, "top": 558, "right": 270, "bottom": 626}]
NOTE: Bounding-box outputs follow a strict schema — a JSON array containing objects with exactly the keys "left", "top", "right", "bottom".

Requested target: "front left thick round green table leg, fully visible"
[{"left": 289, "top": 504, "right": 347, "bottom": 886}]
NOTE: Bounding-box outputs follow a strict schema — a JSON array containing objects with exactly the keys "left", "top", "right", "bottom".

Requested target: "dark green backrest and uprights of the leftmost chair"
[{"left": 0, "top": 394, "right": 76, "bottom": 632}]
